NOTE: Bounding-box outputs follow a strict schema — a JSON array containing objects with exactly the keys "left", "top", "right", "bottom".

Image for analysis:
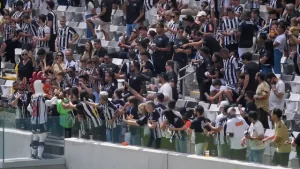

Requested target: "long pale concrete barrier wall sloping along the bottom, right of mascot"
[{"left": 65, "top": 138, "right": 283, "bottom": 169}]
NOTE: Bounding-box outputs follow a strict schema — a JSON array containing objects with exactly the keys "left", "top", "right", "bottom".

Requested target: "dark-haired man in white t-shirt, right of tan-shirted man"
[{"left": 267, "top": 73, "right": 285, "bottom": 110}]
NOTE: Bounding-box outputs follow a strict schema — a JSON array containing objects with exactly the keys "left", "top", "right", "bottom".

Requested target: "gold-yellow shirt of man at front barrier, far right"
[{"left": 275, "top": 120, "right": 291, "bottom": 153}]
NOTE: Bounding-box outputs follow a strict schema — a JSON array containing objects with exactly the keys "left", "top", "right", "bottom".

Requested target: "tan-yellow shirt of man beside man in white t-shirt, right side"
[{"left": 255, "top": 82, "right": 270, "bottom": 112}]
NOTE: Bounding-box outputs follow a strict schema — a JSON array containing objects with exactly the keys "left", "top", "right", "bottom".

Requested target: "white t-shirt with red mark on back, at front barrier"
[{"left": 226, "top": 117, "right": 249, "bottom": 150}]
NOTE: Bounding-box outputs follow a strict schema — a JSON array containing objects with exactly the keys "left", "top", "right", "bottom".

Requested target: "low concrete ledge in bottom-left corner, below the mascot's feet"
[{"left": 0, "top": 158, "right": 66, "bottom": 168}]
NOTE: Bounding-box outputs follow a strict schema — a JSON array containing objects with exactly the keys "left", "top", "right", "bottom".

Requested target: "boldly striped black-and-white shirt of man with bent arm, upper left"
[{"left": 58, "top": 26, "right": 77, "bottom": 50}]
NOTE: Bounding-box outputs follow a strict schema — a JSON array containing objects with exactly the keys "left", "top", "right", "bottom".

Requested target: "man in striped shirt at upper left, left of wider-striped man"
[{"left": 33, "top": 14, "right": 50, "bottom": 52}]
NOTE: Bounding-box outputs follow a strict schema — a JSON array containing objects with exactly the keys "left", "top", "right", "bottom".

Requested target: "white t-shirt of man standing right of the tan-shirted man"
[{"left": 269, "top": 79, "right": 285, "bottom": 110}]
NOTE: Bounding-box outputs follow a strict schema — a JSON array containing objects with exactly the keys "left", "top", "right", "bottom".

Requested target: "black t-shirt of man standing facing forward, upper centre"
[{"left": 153, "top": 34, "right": 170, "bottom": 60}]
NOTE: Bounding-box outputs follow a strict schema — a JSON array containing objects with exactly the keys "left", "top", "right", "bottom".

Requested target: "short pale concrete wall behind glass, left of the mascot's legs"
[{"left": 0, "top": 129, "right": 32, "bottom": 159}]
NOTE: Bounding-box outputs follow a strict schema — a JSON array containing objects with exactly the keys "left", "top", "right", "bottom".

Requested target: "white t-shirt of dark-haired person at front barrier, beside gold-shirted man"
[{"left": 248, "top": 120, "right": 265, "bottom": 150}]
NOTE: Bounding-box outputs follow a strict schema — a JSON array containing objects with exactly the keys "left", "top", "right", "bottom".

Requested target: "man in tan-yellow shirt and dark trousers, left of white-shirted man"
[{"left": 253, "top": 72, "right": 270, "bottom": 129}]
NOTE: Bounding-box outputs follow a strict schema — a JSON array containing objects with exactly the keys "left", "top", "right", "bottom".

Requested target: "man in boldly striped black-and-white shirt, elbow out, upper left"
[{"left": 56, "top": 16, "right": 79, "bottom": 53}]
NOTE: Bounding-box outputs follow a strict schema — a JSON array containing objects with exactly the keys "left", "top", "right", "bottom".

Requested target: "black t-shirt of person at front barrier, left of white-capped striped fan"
[{"left": 190, "top": 117, "right": 210, "bottom": 144}]
